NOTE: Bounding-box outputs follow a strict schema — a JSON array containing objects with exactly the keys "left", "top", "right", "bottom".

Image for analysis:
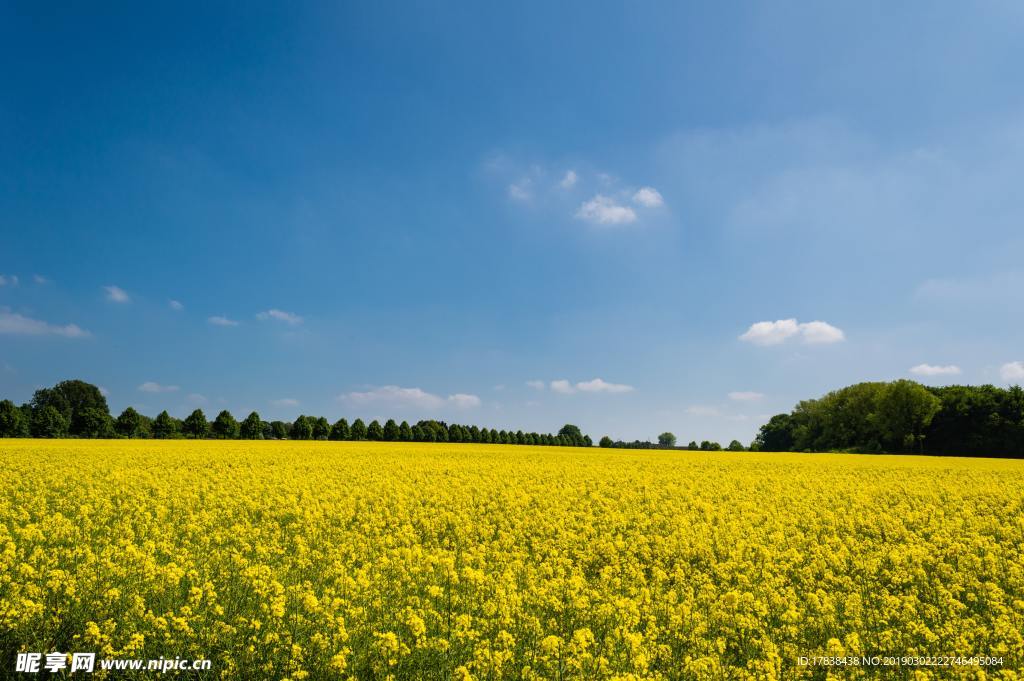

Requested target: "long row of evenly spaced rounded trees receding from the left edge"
[{"left": 0, "top": 380, "right": 593, "bottom": 446}]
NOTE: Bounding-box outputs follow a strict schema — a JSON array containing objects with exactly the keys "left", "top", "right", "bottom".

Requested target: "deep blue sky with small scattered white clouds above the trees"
[{"left": 0, "top": 0, "right": 1024, "bottom": 441}]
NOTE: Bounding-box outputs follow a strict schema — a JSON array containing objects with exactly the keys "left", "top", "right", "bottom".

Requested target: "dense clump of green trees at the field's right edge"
[{"left": 752, "top": 380, "right": 1024, "bottom": 458}]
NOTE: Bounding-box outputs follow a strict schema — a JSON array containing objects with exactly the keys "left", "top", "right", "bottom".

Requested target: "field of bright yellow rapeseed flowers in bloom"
[{"left": 0, "top": 440, "right": 1024, "bottom": 679}]
